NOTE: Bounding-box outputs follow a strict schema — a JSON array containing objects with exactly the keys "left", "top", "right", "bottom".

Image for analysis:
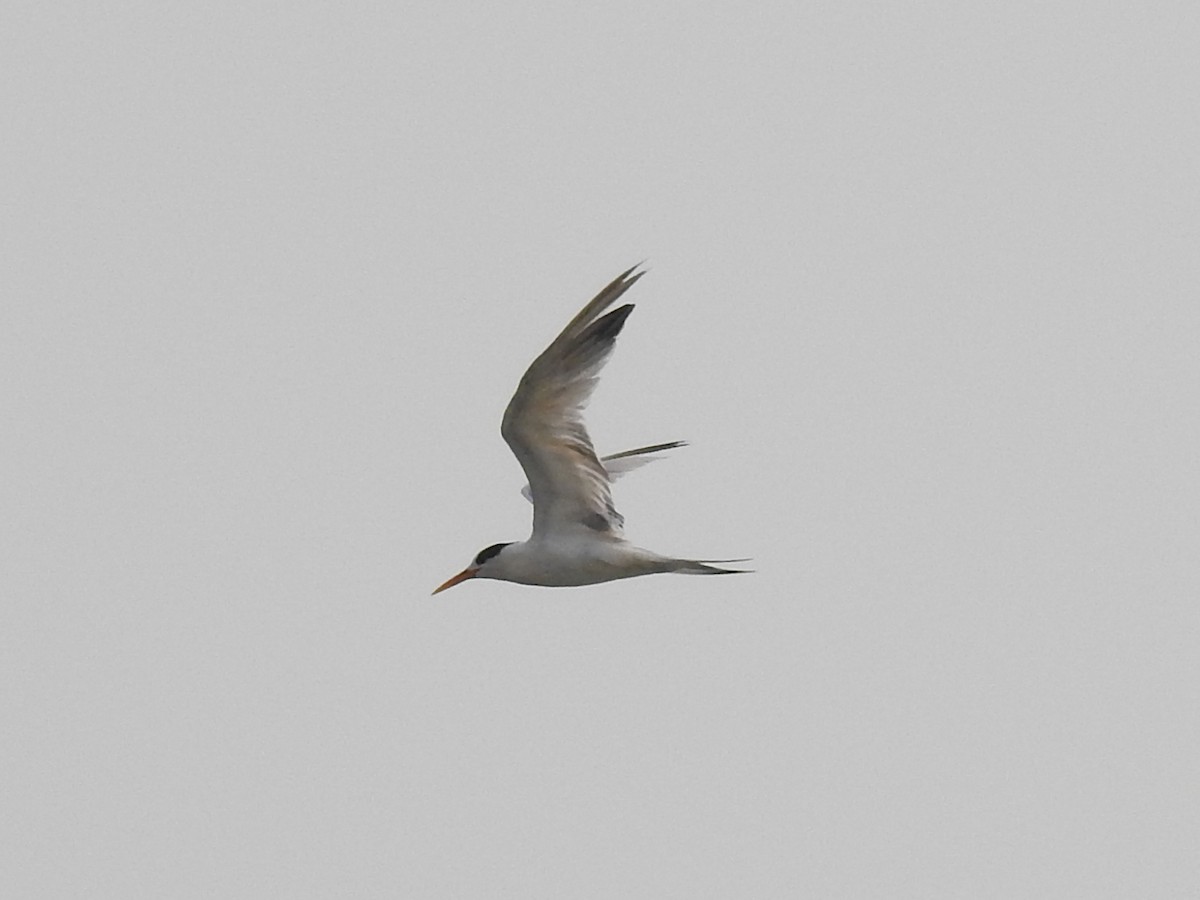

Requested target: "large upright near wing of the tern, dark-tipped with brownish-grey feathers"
[{"left": 500, "top": 266, "right": 642, "bottom": 539}]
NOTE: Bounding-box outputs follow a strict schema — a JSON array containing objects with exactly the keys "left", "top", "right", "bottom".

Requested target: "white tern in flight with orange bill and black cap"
[{"left": 433, "top": 266, "right": 745, "bottom": 594}]
